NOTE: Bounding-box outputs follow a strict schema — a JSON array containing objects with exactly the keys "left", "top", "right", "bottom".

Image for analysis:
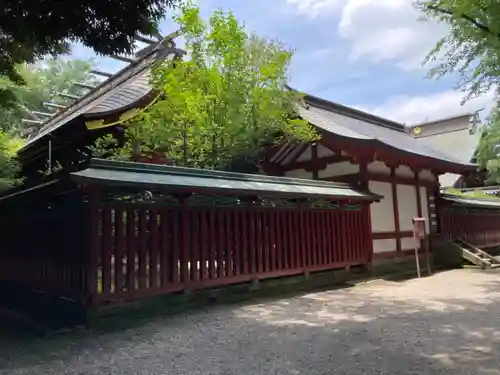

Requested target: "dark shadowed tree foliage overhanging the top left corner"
[{"left": 0, "top": 0, "right": 177, "bottom": 105}]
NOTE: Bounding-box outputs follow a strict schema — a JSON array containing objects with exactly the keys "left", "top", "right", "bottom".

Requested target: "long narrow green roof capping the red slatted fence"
[{"left": 71, "top": 159, "right": 382, "bottom": 201}]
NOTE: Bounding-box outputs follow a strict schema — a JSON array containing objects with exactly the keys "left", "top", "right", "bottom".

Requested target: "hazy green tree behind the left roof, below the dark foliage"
[{"left": 0, "top": 59, "right": 98, "bottom": 135}]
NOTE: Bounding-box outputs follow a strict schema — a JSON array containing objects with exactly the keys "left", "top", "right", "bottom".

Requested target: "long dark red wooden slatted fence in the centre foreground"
[{"left": 91, "top": 202, "right": 372, "bottom": 302}]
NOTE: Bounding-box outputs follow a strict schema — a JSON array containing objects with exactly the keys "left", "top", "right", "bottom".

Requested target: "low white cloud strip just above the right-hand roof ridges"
[{"left": 363, "top": 89, "right": 495, "bottom": 125}]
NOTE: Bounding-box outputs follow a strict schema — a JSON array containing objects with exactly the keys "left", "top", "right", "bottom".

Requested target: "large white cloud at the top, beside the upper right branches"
[{"left": 338, "top": 0, "right": 447, "bottom": 70}]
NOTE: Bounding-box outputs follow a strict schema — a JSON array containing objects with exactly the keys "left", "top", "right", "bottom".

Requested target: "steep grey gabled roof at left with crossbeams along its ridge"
[{"left": 20, "top": 36, "right": 182, "bottom": 153}]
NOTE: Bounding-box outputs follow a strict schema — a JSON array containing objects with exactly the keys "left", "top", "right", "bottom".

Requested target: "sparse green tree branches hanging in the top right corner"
[{"left": 417, "top": 0, "right": 500, "bottom": 100}]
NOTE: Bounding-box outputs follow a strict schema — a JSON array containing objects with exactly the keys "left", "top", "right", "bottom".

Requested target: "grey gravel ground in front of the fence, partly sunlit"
[{"left": 0, "top": 270, "right": 500, "bottom": 375}]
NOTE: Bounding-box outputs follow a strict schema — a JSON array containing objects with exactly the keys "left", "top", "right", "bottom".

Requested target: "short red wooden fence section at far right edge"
[{"left": 441, "top": 210, "right": 500, "bottom": 247}]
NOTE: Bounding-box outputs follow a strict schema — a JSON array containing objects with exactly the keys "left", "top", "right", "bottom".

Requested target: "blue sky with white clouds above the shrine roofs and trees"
[{"left": 73, "top": 0, "right": 493, "bottom": 124}]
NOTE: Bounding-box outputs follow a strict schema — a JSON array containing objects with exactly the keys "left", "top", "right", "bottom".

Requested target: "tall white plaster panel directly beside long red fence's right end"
[{"left": 368, "top": 181, "right": 396, "bottom": 233}]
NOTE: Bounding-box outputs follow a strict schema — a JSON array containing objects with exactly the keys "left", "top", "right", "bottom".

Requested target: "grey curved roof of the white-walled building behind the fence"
[{"left": 297, "top": 97, "right": 475, "bottom": 166}]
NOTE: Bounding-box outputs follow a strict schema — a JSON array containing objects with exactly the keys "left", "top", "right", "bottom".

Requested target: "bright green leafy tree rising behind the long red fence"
[{"left": 94, "top": 3, "right": 316, "bottom": 170}]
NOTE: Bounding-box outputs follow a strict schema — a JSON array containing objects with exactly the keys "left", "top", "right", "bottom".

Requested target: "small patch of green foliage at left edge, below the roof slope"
[{"left": 0, "top": 131, "right": 23, "bottom": 192}]
